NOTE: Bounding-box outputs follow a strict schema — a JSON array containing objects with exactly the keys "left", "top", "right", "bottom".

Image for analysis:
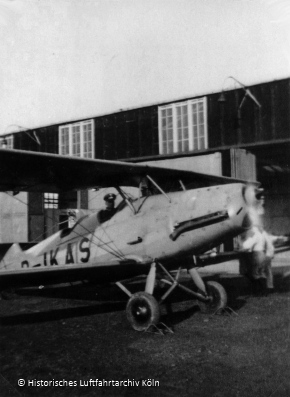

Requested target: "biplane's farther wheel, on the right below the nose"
[{"left": 198, "top": 281, "right": 228, "bottom": 314}]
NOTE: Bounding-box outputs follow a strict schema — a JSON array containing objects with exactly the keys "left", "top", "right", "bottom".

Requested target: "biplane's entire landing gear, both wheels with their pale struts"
[{"left": 116, "top": 262, "right": 227, "bottom": 331}]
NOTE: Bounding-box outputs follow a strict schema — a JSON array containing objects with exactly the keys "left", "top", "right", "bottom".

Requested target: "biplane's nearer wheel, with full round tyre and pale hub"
[{"left": 126, "top": 292, "right": 160, "bottom": 331}]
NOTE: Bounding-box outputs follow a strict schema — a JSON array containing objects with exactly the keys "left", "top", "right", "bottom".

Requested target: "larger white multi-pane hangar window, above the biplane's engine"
[{"left": 159, "top": 97, "right": 207, "bottom": 154}]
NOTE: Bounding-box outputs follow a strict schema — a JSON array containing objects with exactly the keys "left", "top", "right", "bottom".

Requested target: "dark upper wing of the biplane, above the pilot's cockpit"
[{"left": 0, "top": 149, "right": 250, "bottom": 192}]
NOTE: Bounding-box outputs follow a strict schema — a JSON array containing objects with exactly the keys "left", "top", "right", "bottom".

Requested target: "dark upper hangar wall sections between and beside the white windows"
[{"left": 8, "top": 79, "right": 290, "bottom": 159}]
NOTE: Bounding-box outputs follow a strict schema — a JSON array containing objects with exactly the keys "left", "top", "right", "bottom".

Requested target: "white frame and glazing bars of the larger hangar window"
[{"left": 158, "top": 97, "right": 208, "bottom": 154}]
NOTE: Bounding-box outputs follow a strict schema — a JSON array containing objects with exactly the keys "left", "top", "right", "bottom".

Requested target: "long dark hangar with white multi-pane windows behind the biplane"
[{"left": 0, "top": 78, "right": 290, "bottom": 243}]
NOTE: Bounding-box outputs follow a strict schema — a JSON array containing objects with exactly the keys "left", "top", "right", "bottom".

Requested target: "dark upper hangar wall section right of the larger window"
[{"left": 208, "top": 79, "right": 290, "bottom": 148}]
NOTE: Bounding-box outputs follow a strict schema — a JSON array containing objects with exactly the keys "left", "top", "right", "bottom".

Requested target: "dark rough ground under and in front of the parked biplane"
[{"left": 0, "top": 275, "right": 290, "bottom": 397}]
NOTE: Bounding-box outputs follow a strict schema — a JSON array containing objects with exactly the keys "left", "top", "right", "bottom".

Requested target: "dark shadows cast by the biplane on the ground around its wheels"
[{"left": 1, "top": 274, "right": 290, "bottom": 326}]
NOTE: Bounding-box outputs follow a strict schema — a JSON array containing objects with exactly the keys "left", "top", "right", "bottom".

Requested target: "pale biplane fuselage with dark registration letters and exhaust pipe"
[{"left": 0, "top": 183, "right": 247, "bottom": 281}]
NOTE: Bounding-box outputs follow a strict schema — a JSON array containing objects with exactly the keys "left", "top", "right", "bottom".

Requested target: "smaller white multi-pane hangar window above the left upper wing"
[{"left": 59, "top": 120, "right": 94, "bottom": 158}]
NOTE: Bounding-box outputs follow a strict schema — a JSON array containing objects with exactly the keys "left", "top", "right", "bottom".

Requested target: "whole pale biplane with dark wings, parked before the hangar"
[{"left": 0, "top": 149, "right": 258, "bottom": 331}]
